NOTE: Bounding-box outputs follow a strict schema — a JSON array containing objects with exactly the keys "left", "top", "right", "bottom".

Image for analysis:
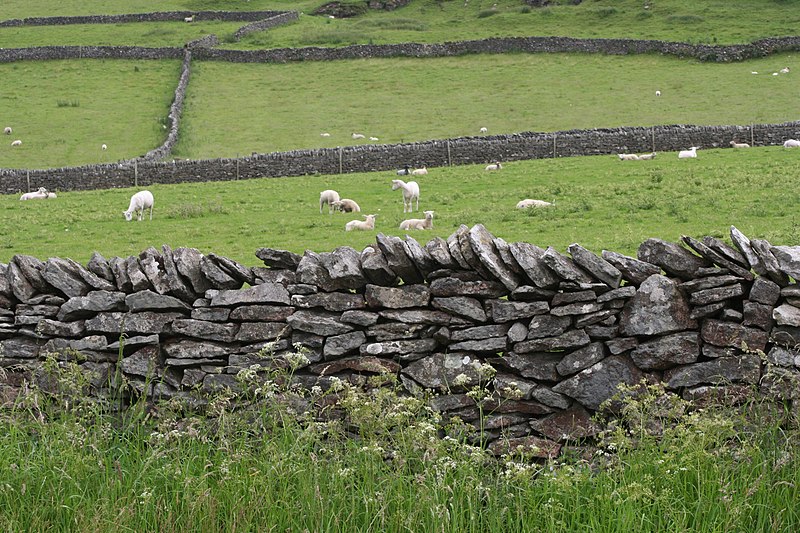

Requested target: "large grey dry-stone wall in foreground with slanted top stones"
[{"left": 0, "top": 225, "right": 800, "bottom": 456}]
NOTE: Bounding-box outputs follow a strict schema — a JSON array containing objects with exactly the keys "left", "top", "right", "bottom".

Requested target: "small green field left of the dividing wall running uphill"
[{"left": 0, "top": 60, "right": 180, "bottom": 168}]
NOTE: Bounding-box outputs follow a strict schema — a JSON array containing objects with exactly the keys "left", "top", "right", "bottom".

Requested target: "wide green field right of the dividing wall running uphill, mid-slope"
[{"left": 175, "top": 54, "right": 800, "bottom": 159}]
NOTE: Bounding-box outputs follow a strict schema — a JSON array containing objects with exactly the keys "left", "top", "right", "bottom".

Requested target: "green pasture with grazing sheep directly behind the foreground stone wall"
[{"left": 0, "top": 147, "right": 800, "bottom": 265}]
